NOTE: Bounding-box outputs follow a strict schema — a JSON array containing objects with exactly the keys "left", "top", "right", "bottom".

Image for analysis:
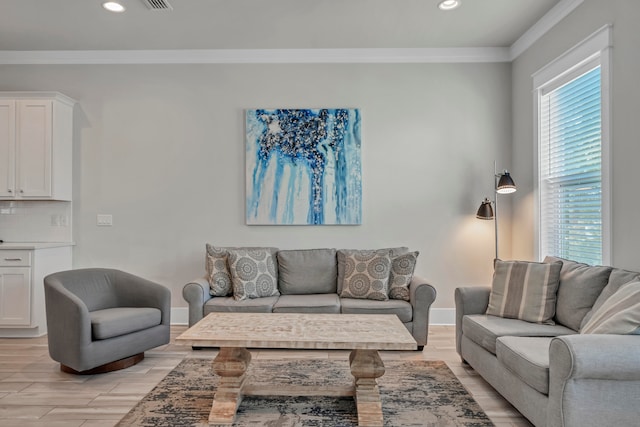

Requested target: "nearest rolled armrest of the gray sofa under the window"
[{"left": 547, "top": 334, "right": 640, "bottom": 426}]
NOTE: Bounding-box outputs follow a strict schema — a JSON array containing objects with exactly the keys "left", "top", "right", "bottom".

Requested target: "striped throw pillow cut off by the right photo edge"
[{"left": 580, "top": 282, "right": 640, "bottom": 335}]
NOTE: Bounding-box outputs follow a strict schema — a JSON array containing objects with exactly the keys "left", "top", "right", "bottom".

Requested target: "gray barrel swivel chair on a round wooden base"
[{"left": 44, "top": 268, "right": 171, "bottom": 374}]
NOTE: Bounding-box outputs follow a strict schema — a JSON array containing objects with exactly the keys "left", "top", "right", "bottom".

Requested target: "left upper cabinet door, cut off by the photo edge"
[{"left": 0, "top": 99, "right": 16, "bottom": 198}]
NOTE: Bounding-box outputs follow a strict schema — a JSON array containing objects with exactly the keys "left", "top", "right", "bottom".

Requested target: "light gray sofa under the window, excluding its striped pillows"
[{"left": 455, "top": 257, "right": 640, "bottom": 427}]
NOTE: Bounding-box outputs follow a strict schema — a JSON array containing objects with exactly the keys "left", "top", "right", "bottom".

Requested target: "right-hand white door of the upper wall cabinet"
[{"left": 16, "top": 100, "right": 53, "bottom": 198}]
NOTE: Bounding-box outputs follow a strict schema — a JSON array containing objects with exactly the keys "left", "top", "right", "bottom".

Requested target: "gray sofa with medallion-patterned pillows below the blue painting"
[{"left": 182, "top": 244, "right": 436, "bottom": 349}]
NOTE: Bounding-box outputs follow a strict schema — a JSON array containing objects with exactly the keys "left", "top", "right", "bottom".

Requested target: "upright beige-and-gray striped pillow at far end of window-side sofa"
[{"left": 486, "top": 259, "right": 562, "bottom": 325}]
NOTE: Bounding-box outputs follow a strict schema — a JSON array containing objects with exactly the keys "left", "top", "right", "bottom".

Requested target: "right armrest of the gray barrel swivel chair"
[{"left": 114, "top": 270, "right": 171, "bottom": 325}]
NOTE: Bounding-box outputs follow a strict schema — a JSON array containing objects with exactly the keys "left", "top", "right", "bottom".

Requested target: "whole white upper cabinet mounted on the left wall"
[{"left": 0, "top": 92, "right": 75, "bottom": 200}]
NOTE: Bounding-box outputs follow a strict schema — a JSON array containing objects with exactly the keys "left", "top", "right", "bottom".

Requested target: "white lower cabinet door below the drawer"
[{"left": 0, "top": 267, "right": 31, "bottom": 326}]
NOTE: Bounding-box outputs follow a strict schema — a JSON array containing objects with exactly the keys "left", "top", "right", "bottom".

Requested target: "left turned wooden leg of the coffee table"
[{"left": 209, "top": 347, "right": 251, "bottom": 424}]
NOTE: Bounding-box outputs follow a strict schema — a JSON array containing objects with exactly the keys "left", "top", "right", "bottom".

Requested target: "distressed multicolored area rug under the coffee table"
[{"left": 118, "top": 358, "right": 493, "bottom": 427}]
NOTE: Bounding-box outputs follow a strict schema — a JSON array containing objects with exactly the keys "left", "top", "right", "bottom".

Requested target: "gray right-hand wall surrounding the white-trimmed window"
[{"left": 512, "top": 0, "right": 640, "bottom": 270}]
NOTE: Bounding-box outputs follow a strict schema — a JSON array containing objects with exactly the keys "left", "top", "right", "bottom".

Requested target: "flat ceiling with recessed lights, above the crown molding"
[{"left": 0, "top": 0, "right": 561, "bottom": 51}]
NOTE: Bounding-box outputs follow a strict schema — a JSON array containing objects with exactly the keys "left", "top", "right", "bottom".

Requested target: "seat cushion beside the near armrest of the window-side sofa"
[{"left": 496, "top": 337, "right": 553, "bottom": 395}]
